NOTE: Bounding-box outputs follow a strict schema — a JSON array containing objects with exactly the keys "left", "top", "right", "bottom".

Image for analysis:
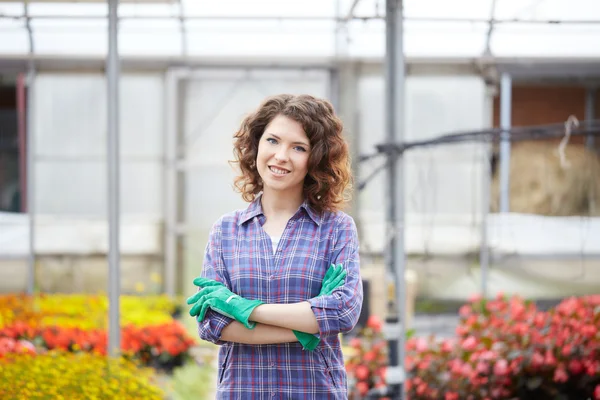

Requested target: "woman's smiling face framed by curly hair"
[{"left": 256, "top": 115, "right": 310, "bottom": 197}]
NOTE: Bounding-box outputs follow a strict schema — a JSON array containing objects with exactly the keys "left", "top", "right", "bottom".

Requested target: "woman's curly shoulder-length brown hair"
[{"left": 231, "top": 94, "right": 352, "bottom": 212}]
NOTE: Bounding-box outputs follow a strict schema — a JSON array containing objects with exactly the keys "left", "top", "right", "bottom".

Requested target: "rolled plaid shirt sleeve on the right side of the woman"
[{"left": 308, "top": 215, "right": 363, "bottom": 338}]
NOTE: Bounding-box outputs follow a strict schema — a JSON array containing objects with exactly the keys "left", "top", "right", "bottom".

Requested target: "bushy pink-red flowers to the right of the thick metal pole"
[{"left": 406, "top": 295, "right": 600, "bottom": 400}]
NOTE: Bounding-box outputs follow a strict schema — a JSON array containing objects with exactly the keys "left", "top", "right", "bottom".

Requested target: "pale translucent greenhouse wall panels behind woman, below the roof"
[{"left": 0, "top": 62, "right": 600, "bottom": 298}]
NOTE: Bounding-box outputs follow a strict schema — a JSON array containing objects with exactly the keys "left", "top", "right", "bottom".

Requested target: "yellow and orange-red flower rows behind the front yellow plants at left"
[{"left": 0, "top": 295, "right": 195, "bottom": 371}]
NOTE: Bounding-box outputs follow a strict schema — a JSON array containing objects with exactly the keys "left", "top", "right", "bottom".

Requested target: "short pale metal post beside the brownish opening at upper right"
[{"left": 500, "top": 73, "right": 512, "bottom": 213}]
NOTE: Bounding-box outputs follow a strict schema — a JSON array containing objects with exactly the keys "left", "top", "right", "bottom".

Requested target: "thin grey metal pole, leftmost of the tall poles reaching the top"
[{"left": 24, "top": 1, "right": 36, "bottom": 295}]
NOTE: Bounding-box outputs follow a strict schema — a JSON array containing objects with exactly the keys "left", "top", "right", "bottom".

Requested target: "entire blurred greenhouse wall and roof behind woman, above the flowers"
[{"left": 0, "top": 0, "right": 600, "bottom": 398}]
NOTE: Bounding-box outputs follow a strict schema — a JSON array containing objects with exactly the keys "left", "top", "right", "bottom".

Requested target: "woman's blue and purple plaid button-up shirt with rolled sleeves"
[{"left": 198, "top": 196, "right": 363, "bottom": 400}]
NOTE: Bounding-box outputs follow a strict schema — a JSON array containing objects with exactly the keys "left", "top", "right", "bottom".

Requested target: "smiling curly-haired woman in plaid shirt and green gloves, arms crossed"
[{"left": 188, "top": 95, "right": 363, "bottom": 400}]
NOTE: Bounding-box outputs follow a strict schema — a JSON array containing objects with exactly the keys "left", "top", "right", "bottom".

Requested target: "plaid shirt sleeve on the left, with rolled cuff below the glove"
[{"left": 197, "top": 221, "right": 233, "bottom": 345}]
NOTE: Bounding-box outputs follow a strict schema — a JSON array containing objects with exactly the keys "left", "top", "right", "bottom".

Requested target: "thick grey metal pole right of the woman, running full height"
[{"left": 385, "top": 0, "right": 406, "bottom": 399}]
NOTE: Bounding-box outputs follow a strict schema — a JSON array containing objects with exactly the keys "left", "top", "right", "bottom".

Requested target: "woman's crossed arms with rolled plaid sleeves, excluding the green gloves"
[{"left": 198, "top": 219, "right": 363, "bottom": 344}]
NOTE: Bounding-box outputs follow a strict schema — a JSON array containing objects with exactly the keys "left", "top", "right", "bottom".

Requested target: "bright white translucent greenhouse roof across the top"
[{"left": 0, "top": 0, "right": 600, "bottom": 59}]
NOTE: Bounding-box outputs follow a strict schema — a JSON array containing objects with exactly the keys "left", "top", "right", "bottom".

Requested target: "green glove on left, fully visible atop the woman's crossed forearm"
[{"left": 187, "top": 278, "right": 263, "bottom": 329}]
